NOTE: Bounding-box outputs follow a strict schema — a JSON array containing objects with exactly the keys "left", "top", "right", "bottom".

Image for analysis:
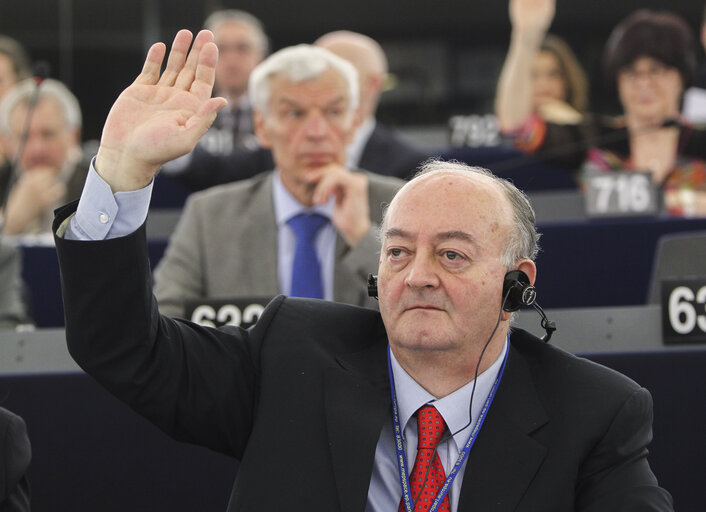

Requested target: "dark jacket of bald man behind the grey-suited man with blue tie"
[{"left": 358, "top": 123, "right": 431, "bottom": 179}]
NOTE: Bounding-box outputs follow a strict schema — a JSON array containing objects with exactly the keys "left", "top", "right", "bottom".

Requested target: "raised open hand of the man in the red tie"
[{"left": 95, "top": 30, "right": 226, "bottom": 192}]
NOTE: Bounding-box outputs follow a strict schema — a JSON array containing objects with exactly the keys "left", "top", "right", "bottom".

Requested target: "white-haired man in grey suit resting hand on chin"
[{"left": 154, "top": 41, "right": 402, "bottom": 315}]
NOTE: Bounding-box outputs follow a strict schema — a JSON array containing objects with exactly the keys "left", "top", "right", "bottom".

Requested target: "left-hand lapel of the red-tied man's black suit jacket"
[{"left": 324, "top": 342, "right": 391, "bottom": 512}]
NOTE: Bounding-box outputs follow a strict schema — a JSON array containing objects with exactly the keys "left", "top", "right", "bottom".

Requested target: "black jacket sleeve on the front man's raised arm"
[{"left": 55, "top": 202, "right": 278, "bottom": 458}]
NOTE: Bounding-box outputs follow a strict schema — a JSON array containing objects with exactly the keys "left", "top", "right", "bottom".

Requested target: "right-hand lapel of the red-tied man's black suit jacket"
[{"left": 459, "top": 346, "right": 548, "bottom": 512}]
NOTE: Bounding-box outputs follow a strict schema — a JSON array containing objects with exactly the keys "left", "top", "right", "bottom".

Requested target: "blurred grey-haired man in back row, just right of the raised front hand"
[{"left": 163, "top": 9, "right": 274, "bottom": 190}]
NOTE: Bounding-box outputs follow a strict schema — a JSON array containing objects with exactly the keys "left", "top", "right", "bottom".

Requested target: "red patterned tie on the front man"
[{"left": 398, "top": 405, "right": 451, "bottom": 512}]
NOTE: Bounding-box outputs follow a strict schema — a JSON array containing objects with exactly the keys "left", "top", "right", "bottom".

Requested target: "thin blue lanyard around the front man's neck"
[{"left": 387, "top": 346, "right": 510, "bottom": 512}]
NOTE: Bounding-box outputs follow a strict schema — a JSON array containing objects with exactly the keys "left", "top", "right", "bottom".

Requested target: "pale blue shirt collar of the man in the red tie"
[{"left": 390, "top": 334, "right": 510, "bottom": 447}]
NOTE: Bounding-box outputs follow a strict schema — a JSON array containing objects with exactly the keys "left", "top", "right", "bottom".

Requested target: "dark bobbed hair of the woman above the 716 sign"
[{"left": 603, "top": 9, "right": 696, "bottom": 90}]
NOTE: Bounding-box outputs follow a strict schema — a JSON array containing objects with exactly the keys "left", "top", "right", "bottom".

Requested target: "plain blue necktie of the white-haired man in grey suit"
[{"left": 287, "top": 213, "right": 328, "bottom": 299}]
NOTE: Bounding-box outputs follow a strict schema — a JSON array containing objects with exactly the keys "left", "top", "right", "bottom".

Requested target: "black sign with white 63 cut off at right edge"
[{"left": 662, "top": 277, "right": 706, "bottom": 344}]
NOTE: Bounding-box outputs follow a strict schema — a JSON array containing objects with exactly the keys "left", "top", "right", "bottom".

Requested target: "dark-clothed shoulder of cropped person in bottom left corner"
[{"left": 0, "top": 407, "right": 32, "bottom": 512}]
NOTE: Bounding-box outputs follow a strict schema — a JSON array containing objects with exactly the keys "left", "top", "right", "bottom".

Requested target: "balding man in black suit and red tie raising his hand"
[{"left": 55, "top": 30, "right": 672, "bottom": 512}]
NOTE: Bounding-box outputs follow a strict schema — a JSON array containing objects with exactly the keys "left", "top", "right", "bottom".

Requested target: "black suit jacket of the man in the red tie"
[{"left": 55, "top": 204, "right": 671, "bottom": 512}]
